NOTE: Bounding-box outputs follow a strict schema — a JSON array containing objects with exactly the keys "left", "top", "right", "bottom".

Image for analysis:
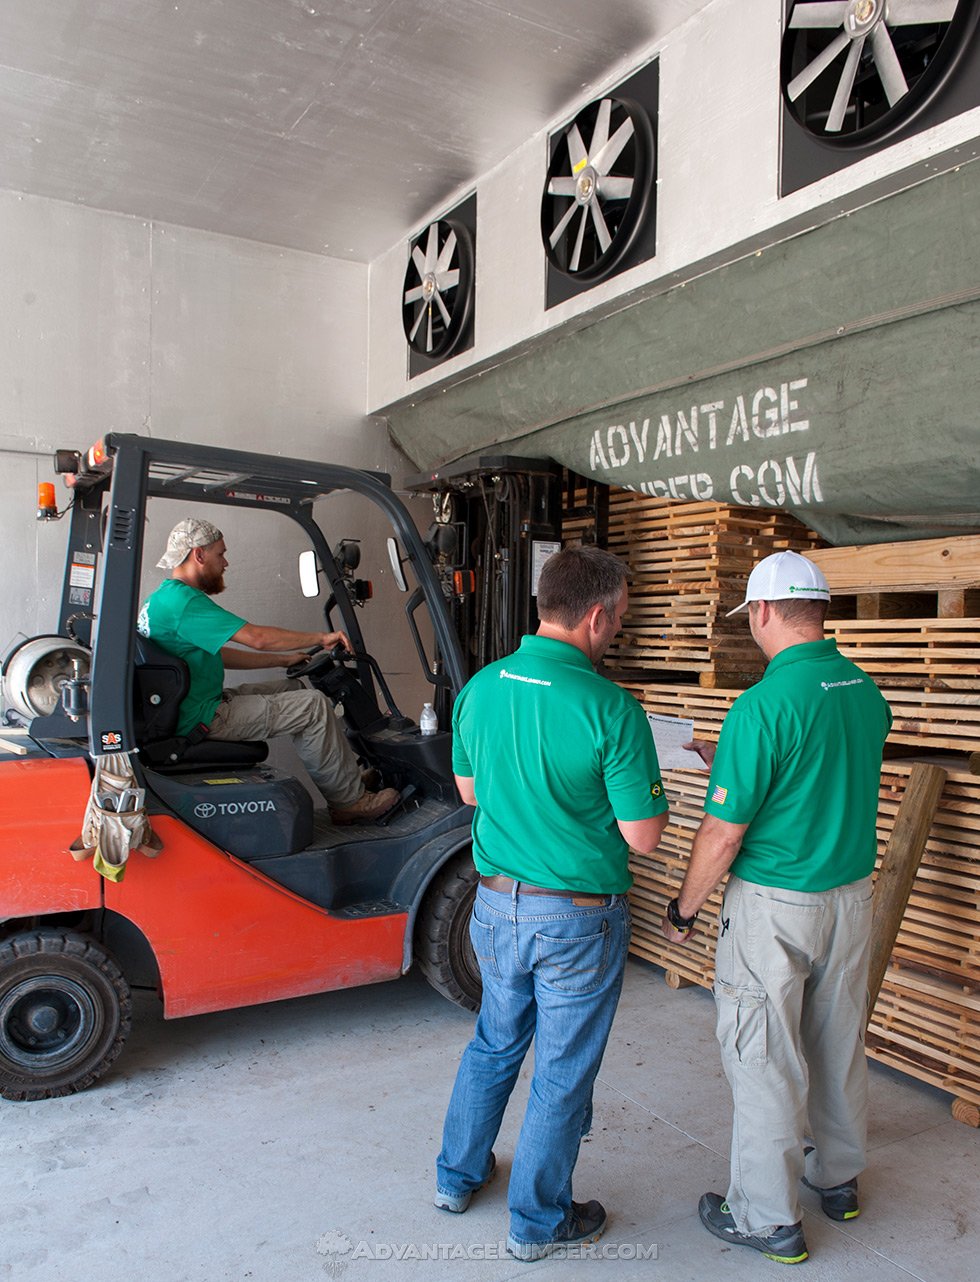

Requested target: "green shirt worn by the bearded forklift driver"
[{"left": 136, "top": 578, "right": 245, "bottom": 735}]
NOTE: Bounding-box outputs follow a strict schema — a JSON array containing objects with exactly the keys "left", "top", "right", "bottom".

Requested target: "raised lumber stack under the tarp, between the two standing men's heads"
[{"left": 608, "top": 491, "right": 818, "bottom": 687}]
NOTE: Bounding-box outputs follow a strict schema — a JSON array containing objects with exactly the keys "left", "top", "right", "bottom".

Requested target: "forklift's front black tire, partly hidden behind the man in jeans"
[{"left": 414, "top": 850, "right": 484, "bottom": 1010}]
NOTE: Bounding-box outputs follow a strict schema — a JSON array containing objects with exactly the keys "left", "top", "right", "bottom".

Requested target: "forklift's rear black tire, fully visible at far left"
[{"left": 0, "top": 929, "right": 132, "bottom": 1100}]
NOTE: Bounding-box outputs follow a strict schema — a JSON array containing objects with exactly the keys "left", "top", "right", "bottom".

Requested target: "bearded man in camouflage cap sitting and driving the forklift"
[{"left": 137, "top": 517, "right": 399, "bottom": 823}]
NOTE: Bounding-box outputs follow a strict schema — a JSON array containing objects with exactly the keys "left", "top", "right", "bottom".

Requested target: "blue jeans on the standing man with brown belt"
[{"left": 436, "top": 885, "right": 630, "bottom": 1242}]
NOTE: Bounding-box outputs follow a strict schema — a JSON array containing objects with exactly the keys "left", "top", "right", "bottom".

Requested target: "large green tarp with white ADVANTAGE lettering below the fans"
[{"left": 389, "top": 164, "right": 980, "bottom": 544}]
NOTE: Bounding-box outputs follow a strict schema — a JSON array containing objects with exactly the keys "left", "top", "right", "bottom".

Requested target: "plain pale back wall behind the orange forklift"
[{"left": 0, "top": 191, "right": 427, "bottom": 733}]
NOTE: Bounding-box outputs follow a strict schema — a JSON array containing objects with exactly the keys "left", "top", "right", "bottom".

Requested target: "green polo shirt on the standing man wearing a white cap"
[{"left": 704, "top": 640, "right": 891, "bottom": 891}]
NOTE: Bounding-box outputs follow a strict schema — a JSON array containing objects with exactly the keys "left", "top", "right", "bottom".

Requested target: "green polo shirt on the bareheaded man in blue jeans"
[{"left": 453, "top": 636, "right": 667, "bottom": 895}]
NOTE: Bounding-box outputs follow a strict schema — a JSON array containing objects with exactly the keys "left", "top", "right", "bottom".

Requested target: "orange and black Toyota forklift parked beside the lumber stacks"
[{"left": 0, "top": 433, "right": 481, "bottom": 1100}]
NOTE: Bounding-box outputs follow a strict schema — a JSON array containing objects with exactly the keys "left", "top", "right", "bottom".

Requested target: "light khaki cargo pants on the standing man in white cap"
[{"left": 714, "top": 877, "right": 871, "bottom": 1235}]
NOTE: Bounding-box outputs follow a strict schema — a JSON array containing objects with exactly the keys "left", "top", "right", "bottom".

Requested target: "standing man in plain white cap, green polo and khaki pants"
[{"left": 663, "top": 551, "right": 891, "bottom": 1264}]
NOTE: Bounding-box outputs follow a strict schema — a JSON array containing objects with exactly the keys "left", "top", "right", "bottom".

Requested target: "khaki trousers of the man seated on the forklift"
[{"left": 208, "top": 679, "right": 364, "bottom": 805}]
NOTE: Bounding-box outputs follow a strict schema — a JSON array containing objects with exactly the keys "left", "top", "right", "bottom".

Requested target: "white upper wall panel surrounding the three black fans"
[{"left": 368, "top": 0, "right": 980, "bottom": 425}]
